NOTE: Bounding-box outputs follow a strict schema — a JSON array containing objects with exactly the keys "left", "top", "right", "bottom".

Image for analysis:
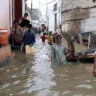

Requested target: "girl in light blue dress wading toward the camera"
[{"left": 51, "top": 34, "right": 68, "bottom": 65}]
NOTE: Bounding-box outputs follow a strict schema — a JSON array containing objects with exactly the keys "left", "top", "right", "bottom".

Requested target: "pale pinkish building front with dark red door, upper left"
[{"left": 0, "top": 0, "right": 26, "bottom": 32}]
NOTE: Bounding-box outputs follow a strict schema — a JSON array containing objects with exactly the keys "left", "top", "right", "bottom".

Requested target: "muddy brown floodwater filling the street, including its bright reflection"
[{"left": 0, "top": 36, "right": 96, "bottom": 96}]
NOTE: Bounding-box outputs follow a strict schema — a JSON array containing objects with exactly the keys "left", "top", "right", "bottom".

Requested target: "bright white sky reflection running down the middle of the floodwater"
[{"left": 25, "top": 35, "right": 56, "bottom": 96}]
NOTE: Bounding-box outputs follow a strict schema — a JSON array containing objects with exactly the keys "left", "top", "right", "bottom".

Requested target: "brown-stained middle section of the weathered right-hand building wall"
[{"left": 62, "top": 8, "right": 90, "bottom": 33}]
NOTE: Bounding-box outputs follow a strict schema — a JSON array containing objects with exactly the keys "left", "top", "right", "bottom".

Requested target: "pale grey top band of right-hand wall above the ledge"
[{"left": 61, "top": 0, "right": 96, "bottom": 11}]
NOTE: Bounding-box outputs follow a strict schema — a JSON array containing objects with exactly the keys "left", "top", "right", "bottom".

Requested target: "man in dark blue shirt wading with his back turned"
[{"left": 22, "top": 24, "right": 35, "bottom": 52}]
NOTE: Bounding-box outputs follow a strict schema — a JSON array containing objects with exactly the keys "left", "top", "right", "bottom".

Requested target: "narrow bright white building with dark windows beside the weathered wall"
[{"left": 46, "top": 0, "right": 61, "bottom": 33}]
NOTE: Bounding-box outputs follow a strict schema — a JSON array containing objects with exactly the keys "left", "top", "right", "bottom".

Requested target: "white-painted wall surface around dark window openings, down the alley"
[{"left": 47, "top": 0, "right": 61, "bottom": 32}]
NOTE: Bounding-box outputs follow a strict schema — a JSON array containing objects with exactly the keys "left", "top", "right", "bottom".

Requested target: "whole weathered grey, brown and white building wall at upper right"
[{"left": 61, "top": 0, "right": 96, "bottom": 34}]
